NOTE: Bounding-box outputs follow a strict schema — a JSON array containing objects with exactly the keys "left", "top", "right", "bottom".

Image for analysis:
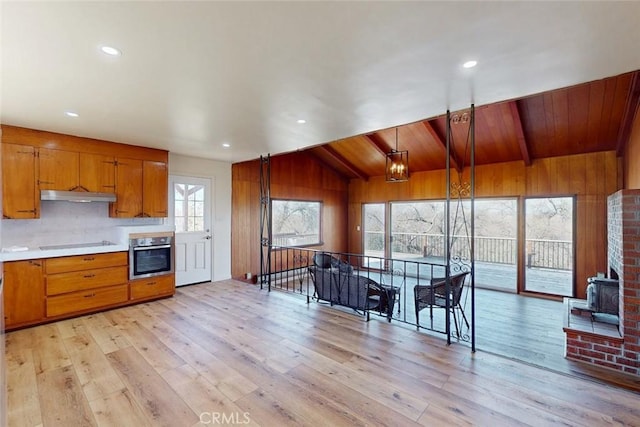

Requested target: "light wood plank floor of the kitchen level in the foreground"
[{"left": 6, "top": 280, "right": 640, "bottom": 427}]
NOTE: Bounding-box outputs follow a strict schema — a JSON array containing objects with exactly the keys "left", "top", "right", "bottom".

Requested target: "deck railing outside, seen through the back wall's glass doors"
[{"left": 365, "top": 231, "right": 573, "bottom": 270}]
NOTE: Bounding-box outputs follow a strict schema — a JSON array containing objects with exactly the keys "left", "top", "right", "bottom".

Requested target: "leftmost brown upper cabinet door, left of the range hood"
[{"left": 2, "top": 144, "right": 40, "bottom": 219}]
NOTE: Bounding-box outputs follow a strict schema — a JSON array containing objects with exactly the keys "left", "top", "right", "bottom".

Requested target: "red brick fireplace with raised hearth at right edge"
[{"left": 565, "top": 190, "right": 640, "bottom": 375}]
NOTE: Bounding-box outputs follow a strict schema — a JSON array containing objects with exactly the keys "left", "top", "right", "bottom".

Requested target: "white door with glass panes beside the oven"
[{"left": 169, "top": 175, "right": 212, "bottom": 286}]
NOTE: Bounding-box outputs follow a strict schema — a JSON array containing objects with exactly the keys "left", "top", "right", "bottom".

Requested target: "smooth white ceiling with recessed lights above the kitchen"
[{"left": 0, "top": 1, "right": 640, "bottom": 162}]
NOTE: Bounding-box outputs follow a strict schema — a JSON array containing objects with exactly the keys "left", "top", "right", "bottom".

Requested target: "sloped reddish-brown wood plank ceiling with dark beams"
[{"left": 306, "top": 71, "right": 640, "bottom": 180}]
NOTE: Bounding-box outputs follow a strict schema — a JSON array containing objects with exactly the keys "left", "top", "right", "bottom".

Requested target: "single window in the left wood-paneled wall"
[{"left": 271, "top": 200, "right": 322, "bottom": 246}]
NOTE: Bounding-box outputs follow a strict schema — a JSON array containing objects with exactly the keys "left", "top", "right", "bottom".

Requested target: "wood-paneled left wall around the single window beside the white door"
[{"left": 231, "top": 153, "right": 348, "bottom": 278}]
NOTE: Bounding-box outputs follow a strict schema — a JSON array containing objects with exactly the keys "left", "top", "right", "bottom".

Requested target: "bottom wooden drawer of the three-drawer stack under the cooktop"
[{"left": 47, "top": 284, "right": 129, "bottom": 317}]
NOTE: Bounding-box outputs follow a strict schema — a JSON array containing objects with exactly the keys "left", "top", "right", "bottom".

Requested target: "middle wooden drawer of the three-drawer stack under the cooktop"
[{"left": 46, "top": 266, "right": 129, "bottom": 295}]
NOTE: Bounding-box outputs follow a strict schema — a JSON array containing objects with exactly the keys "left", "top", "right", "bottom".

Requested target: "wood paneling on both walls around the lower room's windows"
[{"left": 232, "top": 151, "right": 622, "bottom": 298}]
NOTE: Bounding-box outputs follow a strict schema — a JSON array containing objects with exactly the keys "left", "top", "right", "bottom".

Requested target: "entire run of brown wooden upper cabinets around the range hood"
[{"left": 2, "top": 125, "right": 169, "bottom": 219}]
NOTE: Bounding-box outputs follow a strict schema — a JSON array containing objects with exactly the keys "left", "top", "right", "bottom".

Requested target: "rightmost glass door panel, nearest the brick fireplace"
[{"left": 524, "top": 197, "right": 575, "bottom": 297}]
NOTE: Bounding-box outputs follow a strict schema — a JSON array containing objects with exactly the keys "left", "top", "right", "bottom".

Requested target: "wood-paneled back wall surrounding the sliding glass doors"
[{"left": 349, "top": 151, "right": 622, "bottom": 298}]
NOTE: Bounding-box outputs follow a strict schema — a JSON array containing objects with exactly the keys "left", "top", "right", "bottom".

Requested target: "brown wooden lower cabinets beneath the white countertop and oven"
[{"left": 4, "top": 252, "right": 175, "bottom": 330}]
